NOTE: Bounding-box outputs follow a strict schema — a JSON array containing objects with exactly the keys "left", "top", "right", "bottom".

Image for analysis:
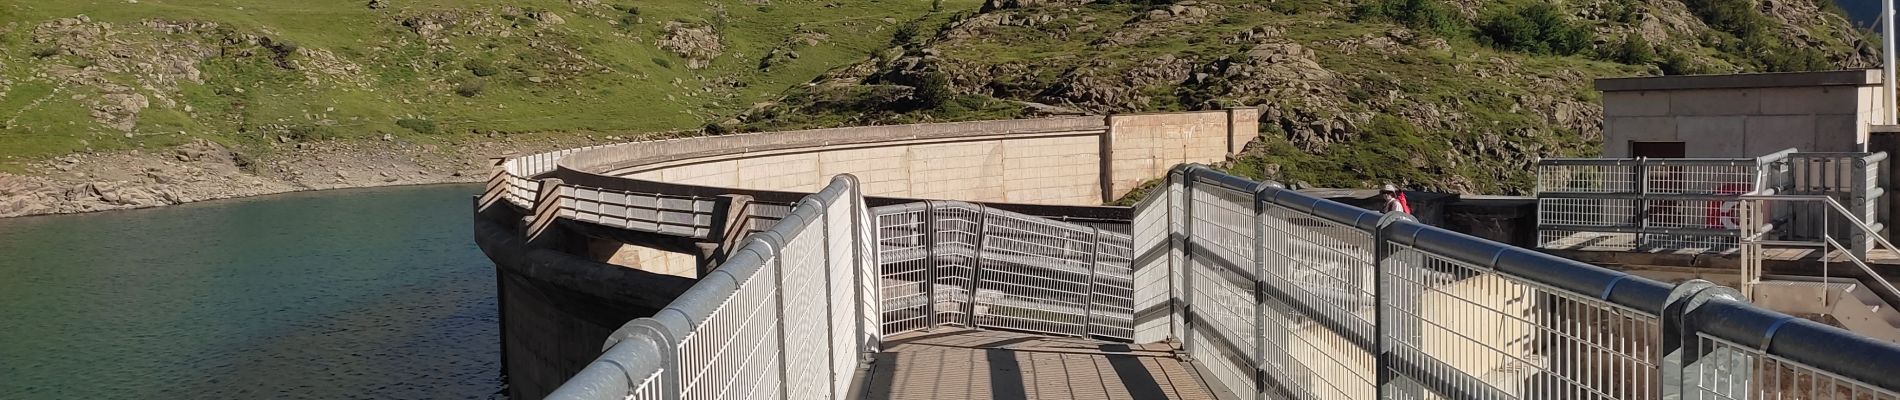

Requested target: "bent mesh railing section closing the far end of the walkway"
[{"left": 872, "top": 201, "right": 1134, "bottom": 341}]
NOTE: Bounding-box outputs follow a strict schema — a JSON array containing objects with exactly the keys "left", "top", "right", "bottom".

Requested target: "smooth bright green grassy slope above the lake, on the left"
[{"left": 0, "top": 0, "right": 979, "bottom": 171}]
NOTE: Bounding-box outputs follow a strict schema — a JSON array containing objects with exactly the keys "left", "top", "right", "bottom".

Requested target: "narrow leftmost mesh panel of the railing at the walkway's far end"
[{"left": 874, "top": 207, "right": 935, "bottom": 336}]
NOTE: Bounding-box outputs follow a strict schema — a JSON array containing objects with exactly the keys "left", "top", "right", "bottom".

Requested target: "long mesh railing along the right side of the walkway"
[{"left": 1132, "top": 167, "right": 1900, "bottom": 398}]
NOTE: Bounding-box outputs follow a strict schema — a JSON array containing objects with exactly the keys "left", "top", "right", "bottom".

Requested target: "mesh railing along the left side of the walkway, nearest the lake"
[{"left": 551, "top": 176, "right": 878, "bottom": 400}]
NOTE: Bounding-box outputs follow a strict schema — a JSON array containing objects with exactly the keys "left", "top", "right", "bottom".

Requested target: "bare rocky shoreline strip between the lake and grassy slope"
[{"left": 0, "top": 136, "right": 595, "bottom": 218}]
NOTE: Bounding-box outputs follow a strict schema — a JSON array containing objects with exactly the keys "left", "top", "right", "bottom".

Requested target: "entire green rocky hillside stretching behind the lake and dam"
[{"left": 0, "top": 0, "right": 1877, "bottom": 196}]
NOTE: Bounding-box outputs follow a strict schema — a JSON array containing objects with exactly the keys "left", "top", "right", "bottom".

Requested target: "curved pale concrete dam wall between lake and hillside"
[{"left": 475, "top": 108, "right": 1258, "bottom": 398}]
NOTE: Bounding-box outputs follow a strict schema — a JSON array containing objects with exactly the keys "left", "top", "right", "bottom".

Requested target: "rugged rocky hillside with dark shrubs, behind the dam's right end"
[{"left": 743, "top": 0, "right": 1877, "bottom": 193}]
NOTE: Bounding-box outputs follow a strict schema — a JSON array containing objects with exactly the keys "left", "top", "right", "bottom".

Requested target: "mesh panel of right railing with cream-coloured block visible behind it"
[{"left": 1383, "top": 243, "right": 1661, "bottom": 398}]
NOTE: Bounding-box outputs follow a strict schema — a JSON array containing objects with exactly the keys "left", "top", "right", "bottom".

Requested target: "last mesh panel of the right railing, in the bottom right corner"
[{"left": 1682, "top": 334, "right": 1900, "bottom": 400}]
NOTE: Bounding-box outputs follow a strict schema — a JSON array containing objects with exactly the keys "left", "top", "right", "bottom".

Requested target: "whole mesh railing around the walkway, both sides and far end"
[{"left": 553, "top": 161, "right": 1900, "bottom": 400}]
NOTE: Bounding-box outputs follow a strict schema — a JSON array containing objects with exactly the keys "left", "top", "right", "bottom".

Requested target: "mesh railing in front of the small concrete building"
[{"left": 1537, "top": 150, "right": 1887, "bottom": 252}]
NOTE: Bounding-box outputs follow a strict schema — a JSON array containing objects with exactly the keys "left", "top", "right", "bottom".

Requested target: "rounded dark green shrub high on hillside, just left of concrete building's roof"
[{"left": 1478, "top": 2, "right": 1590, "bottom": 55}]
